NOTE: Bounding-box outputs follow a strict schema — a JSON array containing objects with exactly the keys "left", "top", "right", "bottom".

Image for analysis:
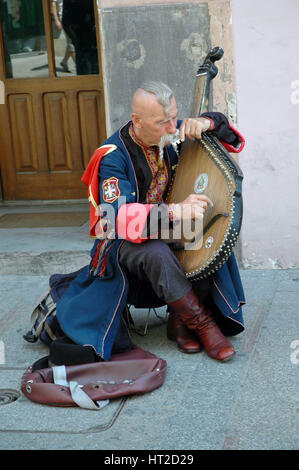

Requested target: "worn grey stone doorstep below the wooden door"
[{"left": 0, "top": 201, "right": 94, "bottom": 276}]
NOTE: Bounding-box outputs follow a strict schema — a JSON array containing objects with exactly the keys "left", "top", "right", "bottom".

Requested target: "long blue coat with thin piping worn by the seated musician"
[{"left": 56, "top": 118, "right": 245, "bottom": 360}]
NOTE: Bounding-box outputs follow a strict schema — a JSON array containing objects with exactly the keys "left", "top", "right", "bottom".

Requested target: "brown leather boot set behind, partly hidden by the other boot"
[{"left": 167, "top": 311, "right": 201, "bottom": 354}]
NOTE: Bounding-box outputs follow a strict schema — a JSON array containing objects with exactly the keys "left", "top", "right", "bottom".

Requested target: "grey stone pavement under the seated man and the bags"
[{"left": 0, "top": 204, "right": 299, "bottom": 451}]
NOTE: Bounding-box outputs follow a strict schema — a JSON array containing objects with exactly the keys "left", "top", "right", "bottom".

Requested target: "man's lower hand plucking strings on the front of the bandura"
[{"left": 172, "top": 194, "right": 213, "bottom": 220}]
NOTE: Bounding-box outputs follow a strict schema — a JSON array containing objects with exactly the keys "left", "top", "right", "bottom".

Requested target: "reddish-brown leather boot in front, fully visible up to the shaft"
[{"left": 169, "top": 289, "right": 235, "bottom": 361}]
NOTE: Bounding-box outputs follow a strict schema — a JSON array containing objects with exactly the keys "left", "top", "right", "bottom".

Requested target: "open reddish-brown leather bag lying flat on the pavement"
[{"left": 21, "top": 347, "right": 167, "bottom": 409}]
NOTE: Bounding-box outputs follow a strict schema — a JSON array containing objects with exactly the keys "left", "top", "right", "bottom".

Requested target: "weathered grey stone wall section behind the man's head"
[{"left": 99, "top": 0, "right": 236, "bottom": 134}]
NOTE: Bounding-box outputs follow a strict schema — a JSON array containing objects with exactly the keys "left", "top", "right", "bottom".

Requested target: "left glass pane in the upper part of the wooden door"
[{"left": 0, "top": 0, "right": 48, "bottom": 78}]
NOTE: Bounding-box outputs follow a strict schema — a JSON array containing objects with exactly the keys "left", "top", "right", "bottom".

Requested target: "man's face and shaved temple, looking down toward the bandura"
[{"left": 133, "top": 97, "right": 178, "bottom": 145}]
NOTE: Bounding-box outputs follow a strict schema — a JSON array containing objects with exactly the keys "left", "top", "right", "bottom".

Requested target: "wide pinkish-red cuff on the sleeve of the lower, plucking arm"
[{"left": 116, "top": 202, "right": 153, "bottom": 243}]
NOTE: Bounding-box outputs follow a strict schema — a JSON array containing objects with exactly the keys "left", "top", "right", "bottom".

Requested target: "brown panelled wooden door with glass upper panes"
[{"left": 0, "top": 0, "right": 106, "bottom": 200}]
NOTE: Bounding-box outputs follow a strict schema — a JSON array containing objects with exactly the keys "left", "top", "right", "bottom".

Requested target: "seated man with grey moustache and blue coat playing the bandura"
[{"left": 57, "top": 82, "right": 244, "bottom": 361}]
